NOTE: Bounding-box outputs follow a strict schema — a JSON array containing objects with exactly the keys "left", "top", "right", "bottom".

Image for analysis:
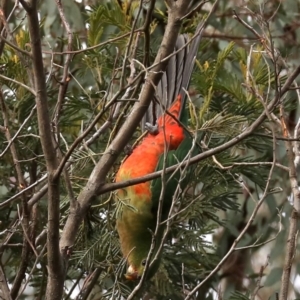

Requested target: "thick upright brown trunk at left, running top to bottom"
[{"left": 21, "top": 0, "right": 64, "bottom": 299}]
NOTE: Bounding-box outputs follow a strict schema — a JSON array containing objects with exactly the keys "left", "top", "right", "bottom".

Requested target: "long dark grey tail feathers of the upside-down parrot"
[{"left": 142, "top": 23, "right": 203, "bottom": 129}]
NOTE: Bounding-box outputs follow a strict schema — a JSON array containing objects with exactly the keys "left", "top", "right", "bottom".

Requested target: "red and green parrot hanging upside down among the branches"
[{"left": 115, "top": 24, "right": 203, "bottom": 281}]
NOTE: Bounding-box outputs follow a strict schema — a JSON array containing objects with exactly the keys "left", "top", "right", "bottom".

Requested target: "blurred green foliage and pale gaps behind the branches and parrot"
[{"left": 0, "top": 0, "right": 300, "bottom": 300}]
